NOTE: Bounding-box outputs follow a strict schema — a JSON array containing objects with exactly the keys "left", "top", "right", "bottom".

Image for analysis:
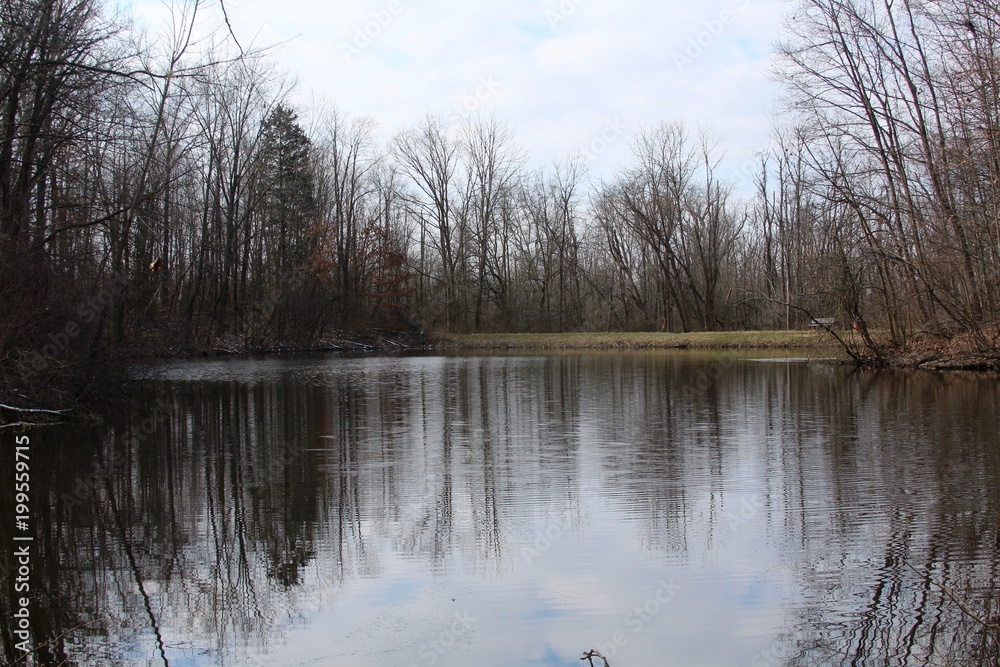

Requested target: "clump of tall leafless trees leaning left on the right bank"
[{"left": 782, "top": 0, "right": 998, "bottom": 342}]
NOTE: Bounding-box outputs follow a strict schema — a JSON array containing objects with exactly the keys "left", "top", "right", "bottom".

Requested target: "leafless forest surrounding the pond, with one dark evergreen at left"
[{"left": 0, "top": 0, "right": 1000, "bottom": 408}]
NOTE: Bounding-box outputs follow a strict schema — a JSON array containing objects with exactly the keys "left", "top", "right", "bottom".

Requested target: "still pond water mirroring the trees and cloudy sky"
[{"left": 0, "top": 352, "right": 1000, "bottom": 667}]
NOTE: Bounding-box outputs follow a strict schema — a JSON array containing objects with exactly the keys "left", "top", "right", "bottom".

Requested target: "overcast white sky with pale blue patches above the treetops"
[{"left": 133, "top": 0, "right": 792, "bottom": 188}]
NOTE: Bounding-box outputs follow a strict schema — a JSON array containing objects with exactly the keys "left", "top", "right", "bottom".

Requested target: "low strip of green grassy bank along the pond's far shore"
[{"left": 440, "top": 331, "right": 835, "bottom": 350}]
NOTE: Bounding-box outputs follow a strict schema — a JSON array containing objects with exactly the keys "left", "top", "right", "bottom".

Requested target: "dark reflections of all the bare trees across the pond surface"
[{"left": 0, "top": 355, "right": 1000, "bottom": 665}]
